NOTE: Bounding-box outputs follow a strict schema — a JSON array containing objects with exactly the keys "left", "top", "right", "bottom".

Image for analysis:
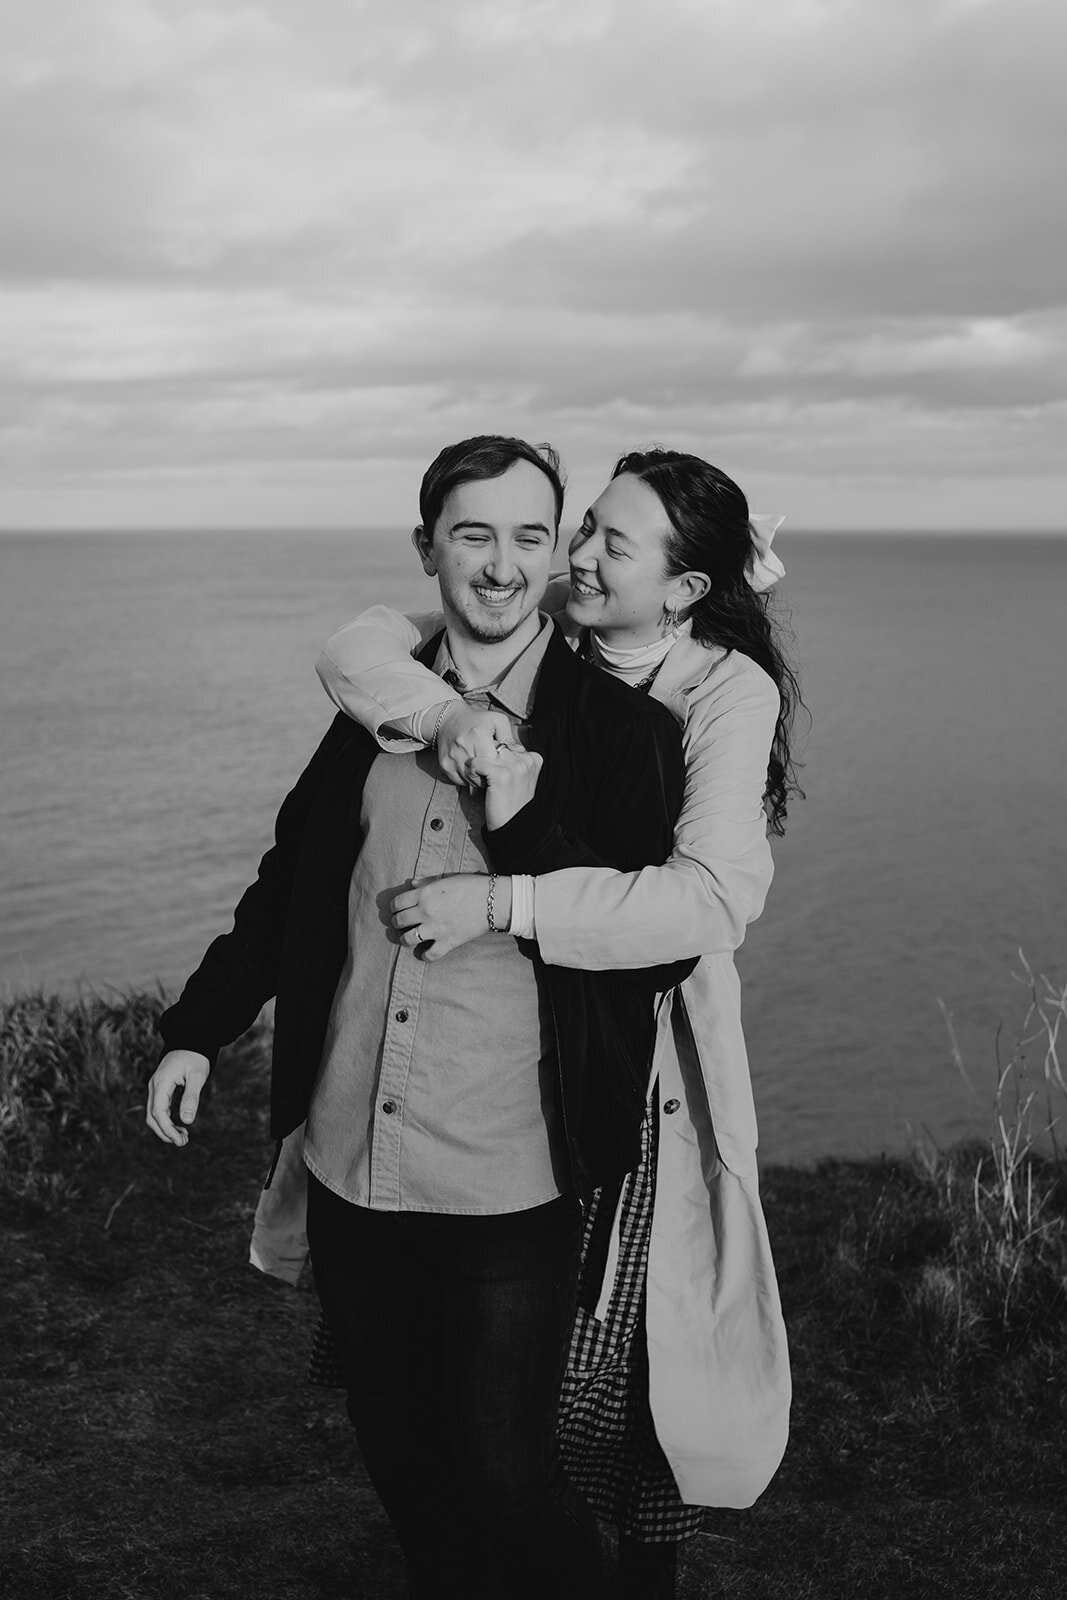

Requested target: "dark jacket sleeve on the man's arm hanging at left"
[{"left": 158, "top": 715, "right": 349, "bottom": 1066}]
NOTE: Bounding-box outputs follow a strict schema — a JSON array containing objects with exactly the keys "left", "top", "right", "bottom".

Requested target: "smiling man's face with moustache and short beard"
[{"left": 413, "top": 461, "right": 557, "bottom": 645}]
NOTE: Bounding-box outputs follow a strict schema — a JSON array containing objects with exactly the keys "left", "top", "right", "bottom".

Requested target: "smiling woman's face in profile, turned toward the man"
[{"left": 566, "top": 472, "right": 678, "bottom": 646}]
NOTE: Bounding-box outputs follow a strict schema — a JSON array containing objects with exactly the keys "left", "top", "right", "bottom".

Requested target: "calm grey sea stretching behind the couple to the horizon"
[{"left": 0, "top": 530, "right": 1067, "bottom": 1163}]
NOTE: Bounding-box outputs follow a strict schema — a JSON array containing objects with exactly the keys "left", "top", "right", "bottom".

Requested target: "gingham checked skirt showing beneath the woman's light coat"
[{"left": 558, "top": 1094, "right": 704, "bottom": 1544}]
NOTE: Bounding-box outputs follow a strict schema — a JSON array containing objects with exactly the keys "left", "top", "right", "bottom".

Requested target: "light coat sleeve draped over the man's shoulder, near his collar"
[{"left": 315, "top": 605, "right": 461, "bottom": 755}]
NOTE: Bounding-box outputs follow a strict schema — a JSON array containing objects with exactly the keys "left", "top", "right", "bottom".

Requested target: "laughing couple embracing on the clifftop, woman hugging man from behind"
[{"left": 149, "top": 435, "right": 798, "bottom": 1600}]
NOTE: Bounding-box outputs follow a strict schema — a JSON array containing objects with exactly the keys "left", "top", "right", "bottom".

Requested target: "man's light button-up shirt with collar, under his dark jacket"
[{"left": 304, "top": 618, "right": 568, "bottom": 1214}]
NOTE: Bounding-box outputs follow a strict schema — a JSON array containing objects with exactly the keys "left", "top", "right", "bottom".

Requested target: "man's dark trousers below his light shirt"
[{"left": 307, "top": 1176, "right": 603, "bottom": 1600}]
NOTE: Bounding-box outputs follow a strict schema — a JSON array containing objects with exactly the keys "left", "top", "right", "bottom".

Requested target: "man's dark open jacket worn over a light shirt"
[{"left": 160, "top": 632, "right": 694, "bottom": 1195}]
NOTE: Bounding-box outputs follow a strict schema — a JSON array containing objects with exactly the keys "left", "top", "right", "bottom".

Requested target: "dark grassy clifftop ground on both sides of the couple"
[{"left": 0, "top": 972, "right": 1067, "bottom": 1600}]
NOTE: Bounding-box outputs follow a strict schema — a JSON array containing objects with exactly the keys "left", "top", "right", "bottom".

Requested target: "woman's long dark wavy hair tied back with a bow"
[{"left": 611, "top": 446, "right": 803, "bottom": 834}]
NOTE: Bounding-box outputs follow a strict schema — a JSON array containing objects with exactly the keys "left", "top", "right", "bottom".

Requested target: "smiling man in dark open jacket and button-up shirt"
[{"left": 147, "top": 437, "right": 688, "bottom": 1600}]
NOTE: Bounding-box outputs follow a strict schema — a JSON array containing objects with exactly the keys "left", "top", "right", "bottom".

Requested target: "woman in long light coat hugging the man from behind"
[{"left": 300, "top": 450, "right": 800, "bottom": 1595}]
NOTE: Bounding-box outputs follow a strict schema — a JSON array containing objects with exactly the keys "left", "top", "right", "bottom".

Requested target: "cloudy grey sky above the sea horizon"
[{"left": 0, "top": 0, "right": 1067, "bottom": 528}]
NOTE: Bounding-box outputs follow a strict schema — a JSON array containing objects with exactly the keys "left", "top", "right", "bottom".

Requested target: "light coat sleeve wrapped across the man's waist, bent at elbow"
[{"left": 534, "top": 653, "right": 779, "bottom": 970}]
